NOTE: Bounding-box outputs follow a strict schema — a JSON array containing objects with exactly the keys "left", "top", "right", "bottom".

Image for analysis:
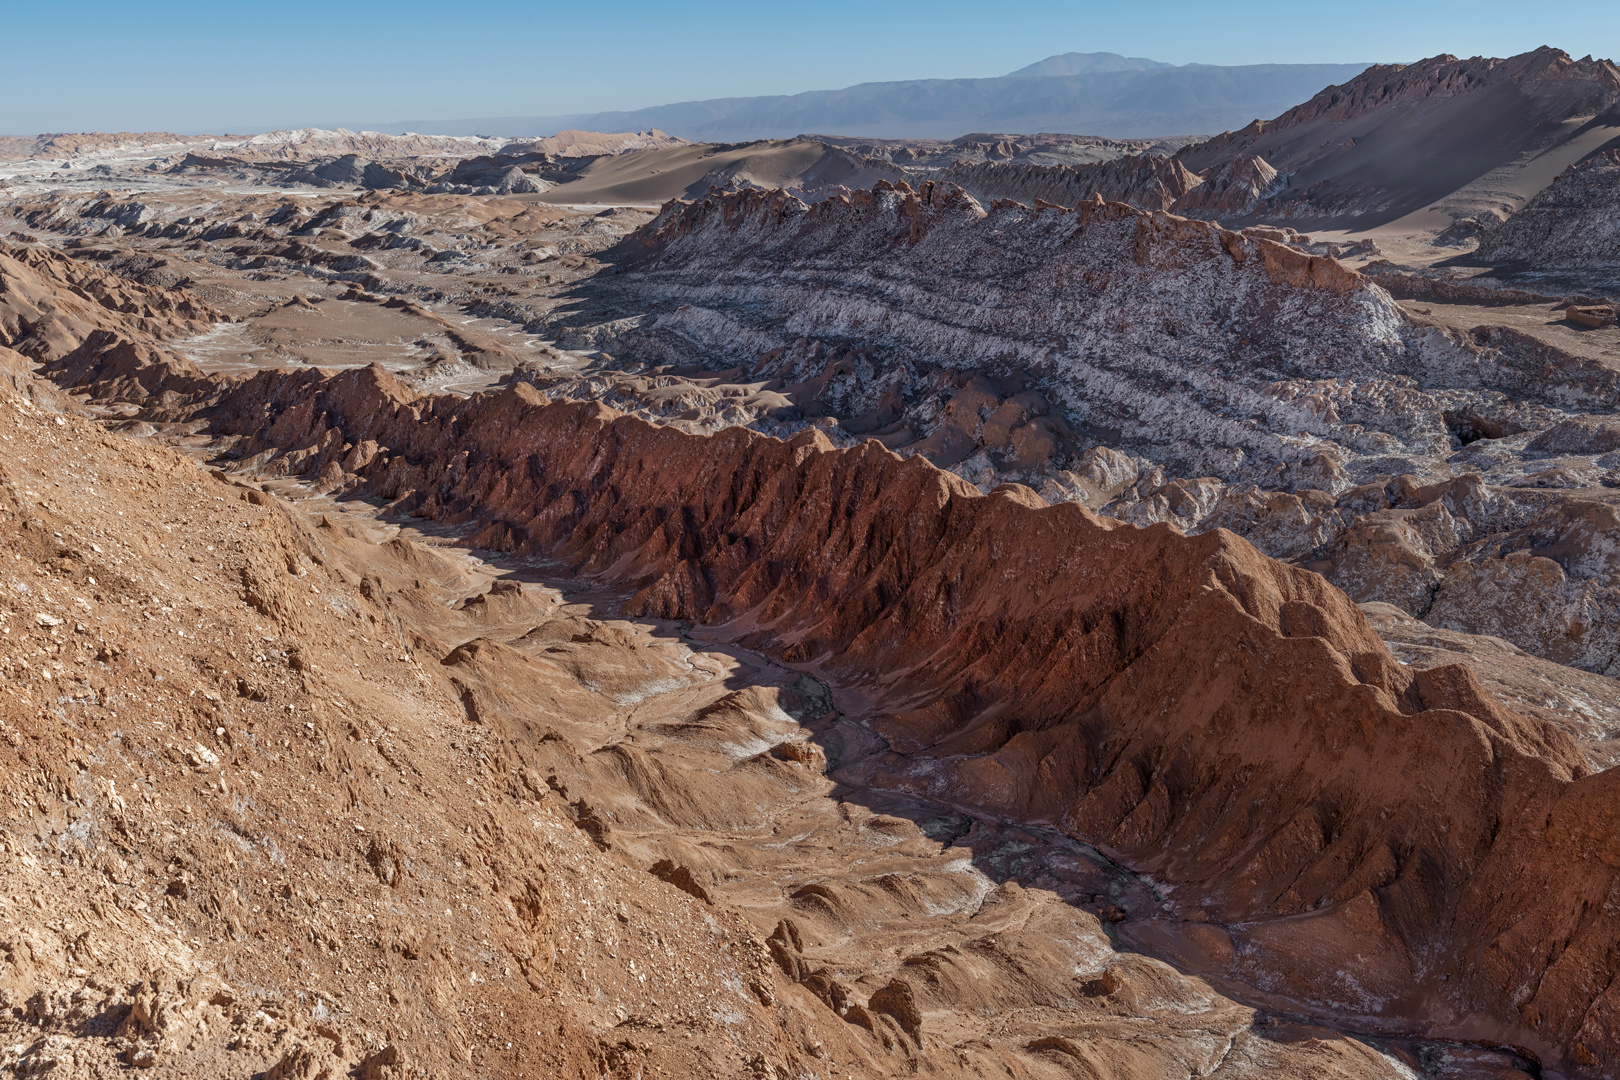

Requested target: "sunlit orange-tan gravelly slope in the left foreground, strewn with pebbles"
[{"left": 0, "top": 374, "right": 842, "bottom": 1080}]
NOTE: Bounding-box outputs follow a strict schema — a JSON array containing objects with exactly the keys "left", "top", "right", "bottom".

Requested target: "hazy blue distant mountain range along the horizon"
[{"left": 363, "top": 52, "right": 1367, "bottom": 142}]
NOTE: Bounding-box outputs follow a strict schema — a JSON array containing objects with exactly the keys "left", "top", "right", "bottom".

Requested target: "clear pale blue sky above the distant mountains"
[{"left": 0, "top": 0, "right": 1620, "bottom": 134}]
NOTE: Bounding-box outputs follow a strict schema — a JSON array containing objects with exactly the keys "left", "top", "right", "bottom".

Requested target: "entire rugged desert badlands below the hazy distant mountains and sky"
[{"left": 0, "top": 49, "right": 1620, "bottom": 1080}]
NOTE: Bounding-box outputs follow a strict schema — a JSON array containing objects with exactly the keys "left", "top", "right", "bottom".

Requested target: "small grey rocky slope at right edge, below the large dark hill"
[{"left": 1476, "top": 149, "right": 1620, "bottom": 269}]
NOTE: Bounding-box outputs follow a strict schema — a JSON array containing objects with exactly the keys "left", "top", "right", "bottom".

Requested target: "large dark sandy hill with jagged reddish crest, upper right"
[{"left": 1178, "top": 47, "right": 1620, "bottom": 228}]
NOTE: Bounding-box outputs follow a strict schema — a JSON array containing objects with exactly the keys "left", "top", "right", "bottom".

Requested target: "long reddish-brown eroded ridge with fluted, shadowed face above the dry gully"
[{"left": 59, "top": 335, "right": 1620, "bottom": 1067}]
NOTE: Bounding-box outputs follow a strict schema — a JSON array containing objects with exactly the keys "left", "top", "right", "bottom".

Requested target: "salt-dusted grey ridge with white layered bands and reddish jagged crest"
[{"left": 583, "top": 183, "right": 1529, "bottom": 483}]
